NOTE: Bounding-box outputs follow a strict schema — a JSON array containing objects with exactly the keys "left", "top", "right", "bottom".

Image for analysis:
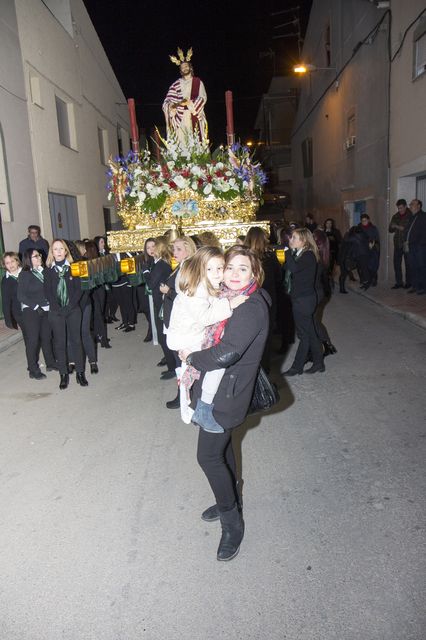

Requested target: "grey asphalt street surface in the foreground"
[{"left": 0, "top": 292, "right": 426, "bottom": 640}]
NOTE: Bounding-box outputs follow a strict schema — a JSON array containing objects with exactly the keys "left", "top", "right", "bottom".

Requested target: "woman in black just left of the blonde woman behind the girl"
[{"left": 143, "top": 236, "right": 176, "bottom": 380}]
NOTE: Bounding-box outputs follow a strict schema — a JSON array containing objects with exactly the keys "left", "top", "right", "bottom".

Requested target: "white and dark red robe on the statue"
[{"left": 163, "top": 76, "right": 207, "bottom": 147}]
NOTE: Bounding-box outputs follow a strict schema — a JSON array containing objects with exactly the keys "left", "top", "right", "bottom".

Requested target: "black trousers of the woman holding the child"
[{"left": 197, "top": 429, "right": 237, "bottom": 511}]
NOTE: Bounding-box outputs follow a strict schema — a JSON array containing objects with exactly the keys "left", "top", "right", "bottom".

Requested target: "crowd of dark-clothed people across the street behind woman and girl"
[{"left": 1, "top": 199, "right": 426, "bottom": 388}]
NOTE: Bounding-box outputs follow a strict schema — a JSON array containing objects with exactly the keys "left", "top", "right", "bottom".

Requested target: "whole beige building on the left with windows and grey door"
[{"left": 0, "top": 0, "right": 129, "bottom": 255}]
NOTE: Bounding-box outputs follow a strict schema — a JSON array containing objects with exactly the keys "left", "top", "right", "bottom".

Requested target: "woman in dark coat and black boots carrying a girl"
[{"left": 179, "top": 245, "right": 271, "bottom": 561}]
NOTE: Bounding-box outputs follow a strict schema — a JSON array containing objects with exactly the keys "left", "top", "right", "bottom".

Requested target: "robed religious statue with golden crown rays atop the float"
[{"left": 163, "top": 48, "right": 208, "bottom": 149}]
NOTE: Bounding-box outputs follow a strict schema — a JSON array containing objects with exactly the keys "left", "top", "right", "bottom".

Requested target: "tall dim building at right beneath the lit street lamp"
[{"left": 292, "top": 0, "right": 389, "bottom": 277}]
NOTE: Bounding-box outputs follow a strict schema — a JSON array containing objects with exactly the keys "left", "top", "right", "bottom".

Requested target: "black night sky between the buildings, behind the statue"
[{"left": 83, "top": 0, "right": 312, "bottom": 145}]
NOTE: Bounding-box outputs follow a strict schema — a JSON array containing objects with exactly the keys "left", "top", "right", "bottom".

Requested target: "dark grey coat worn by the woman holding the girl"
[{"left": 190, "top": 289, "right": 271, "bottom": 430}]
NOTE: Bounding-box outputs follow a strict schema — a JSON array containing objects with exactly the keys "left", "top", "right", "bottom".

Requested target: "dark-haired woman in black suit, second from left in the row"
[{"left": 18, "top": 249, "right": 58, "bottom": 380}]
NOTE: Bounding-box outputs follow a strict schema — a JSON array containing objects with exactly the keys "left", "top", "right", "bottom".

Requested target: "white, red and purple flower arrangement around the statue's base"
[{"left": 107, "top": 136, "right": 266, "bottom": 220}]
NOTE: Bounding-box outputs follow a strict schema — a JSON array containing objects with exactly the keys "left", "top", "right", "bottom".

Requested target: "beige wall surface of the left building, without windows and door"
[{"left": 16, "top": 0, "right": 129, "bottom": 239}]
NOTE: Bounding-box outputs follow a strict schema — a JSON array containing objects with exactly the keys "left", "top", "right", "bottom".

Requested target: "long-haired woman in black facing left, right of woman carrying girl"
[{"left": 284, "top": 228, "right": 325, "bottom": 376}]
